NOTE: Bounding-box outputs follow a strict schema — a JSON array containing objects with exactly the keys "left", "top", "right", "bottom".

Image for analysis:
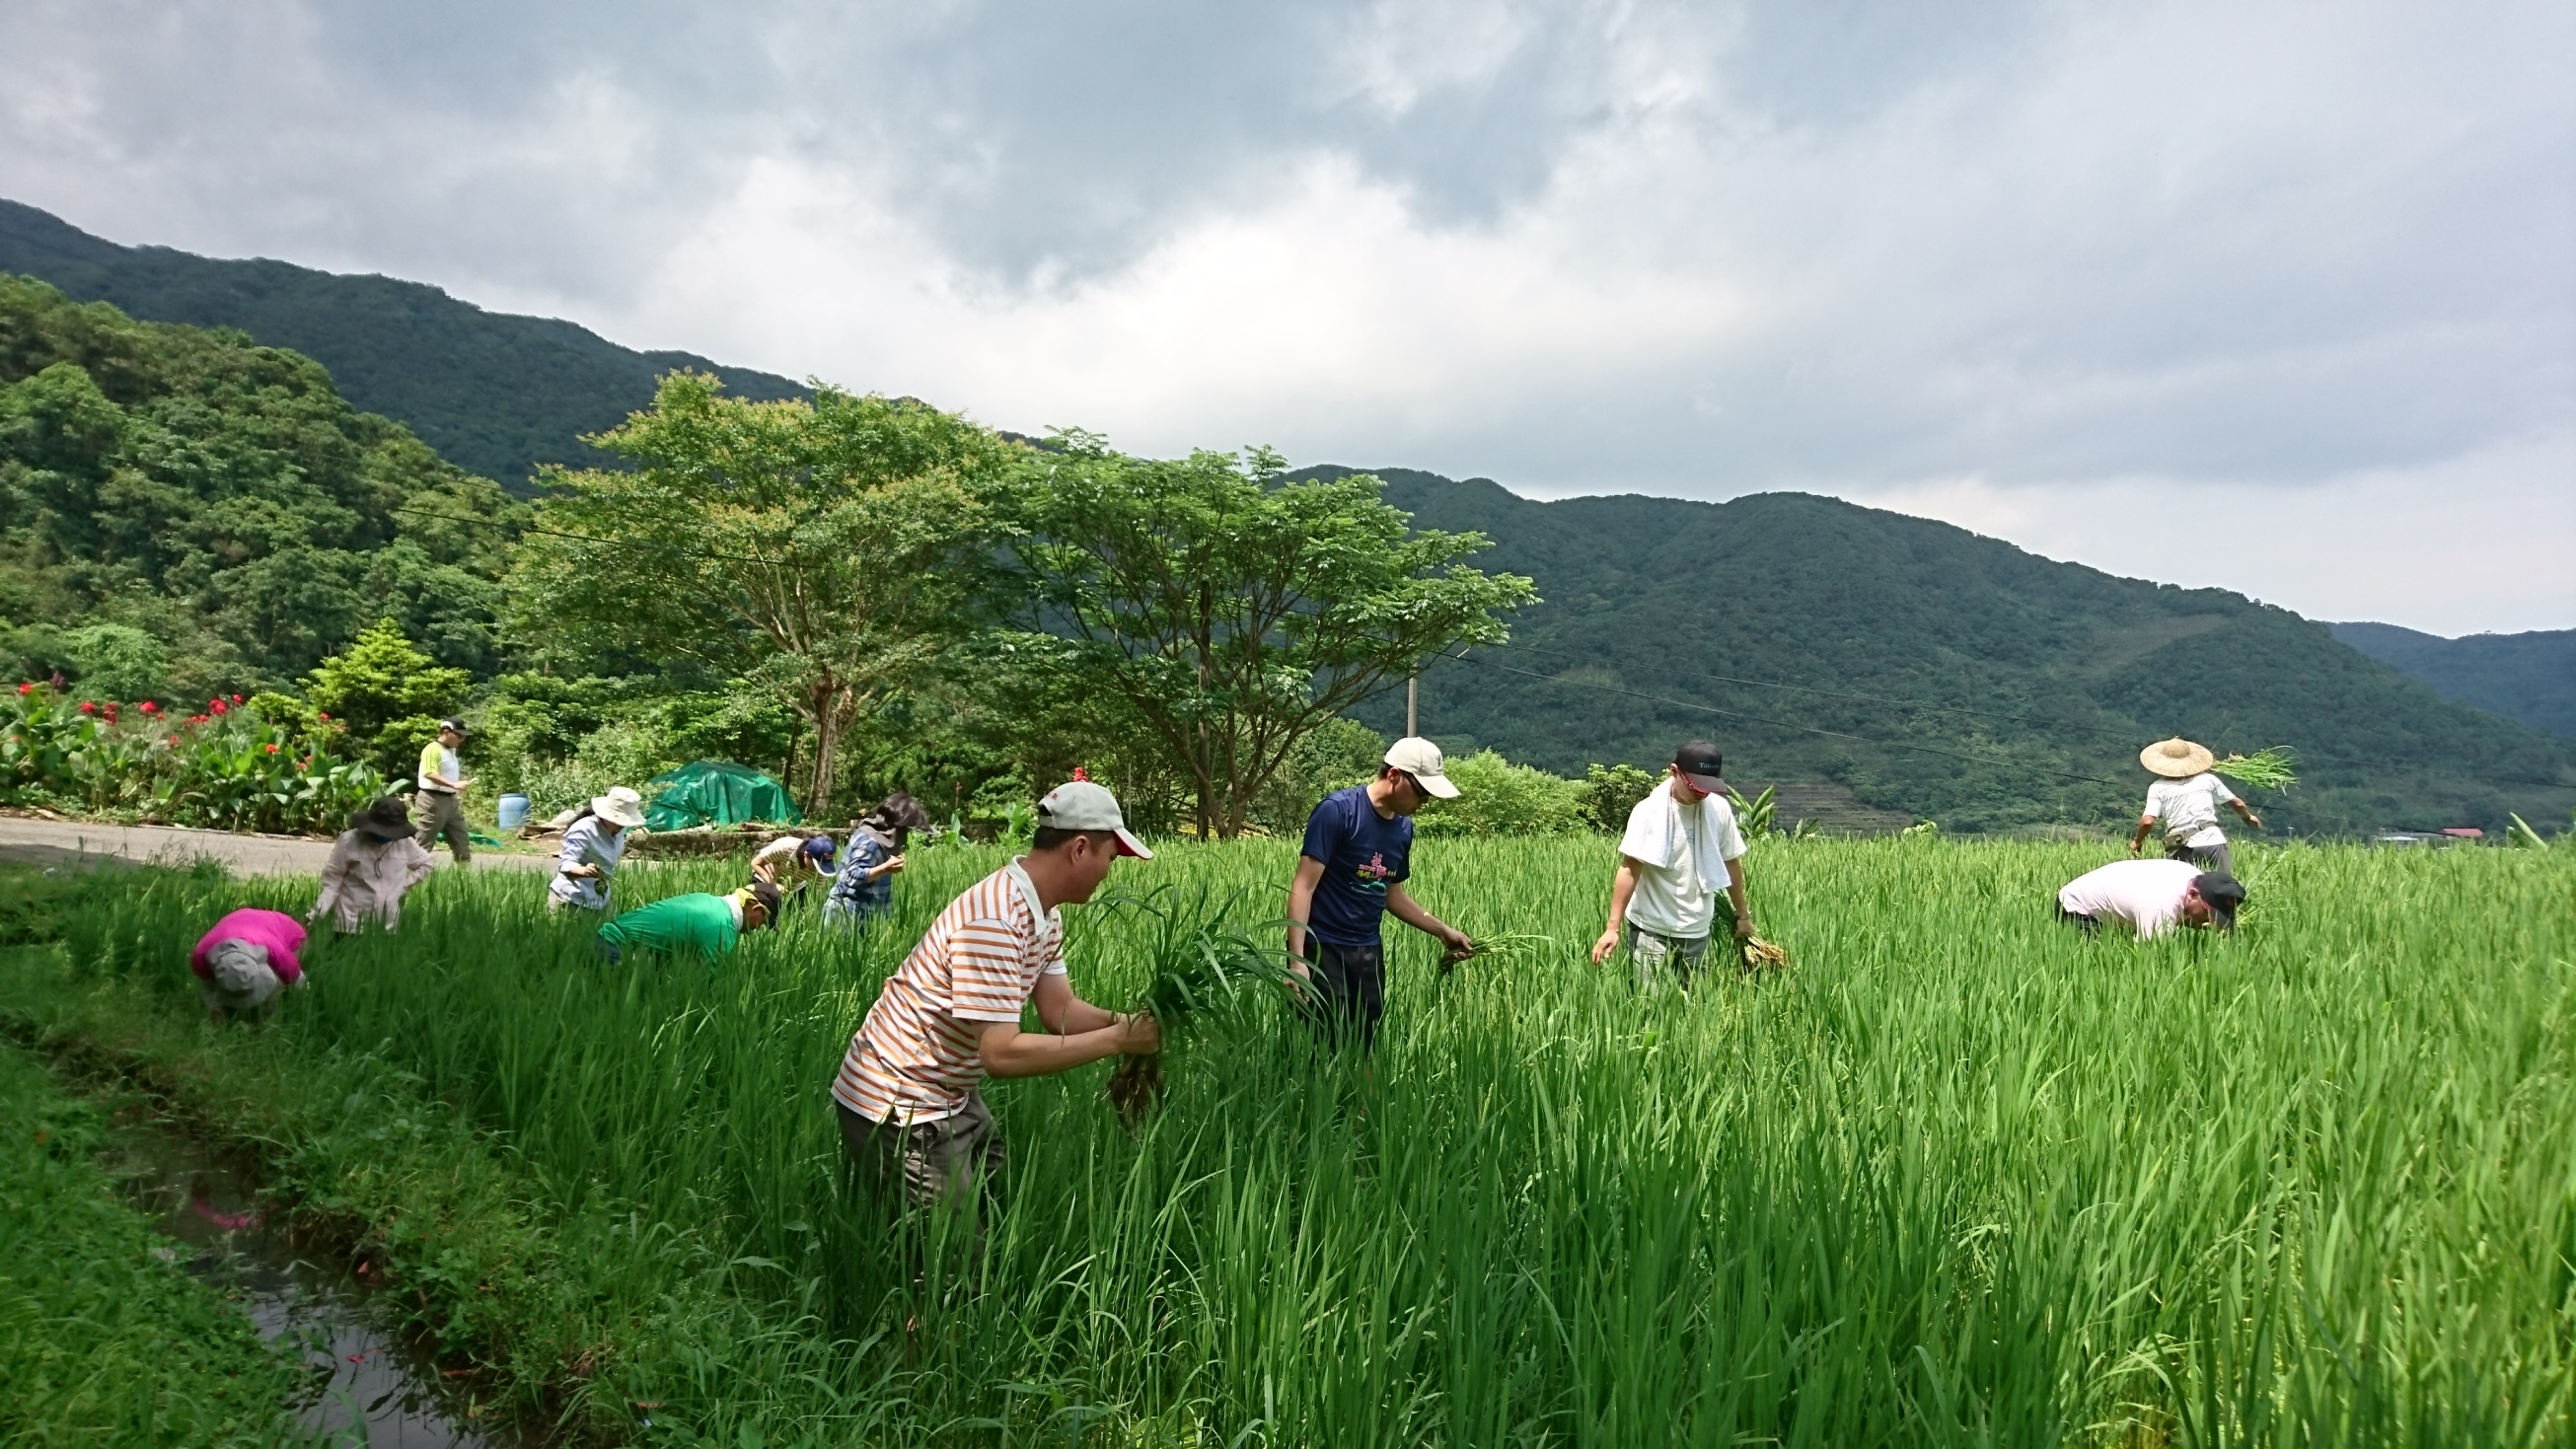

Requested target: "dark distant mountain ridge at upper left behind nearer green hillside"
[{"left": 0, "top": 201, "right": 804, "bottom": 494}]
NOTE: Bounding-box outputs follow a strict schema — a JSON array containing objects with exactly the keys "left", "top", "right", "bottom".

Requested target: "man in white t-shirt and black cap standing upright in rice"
[{"left": 1592, "top": 739, "right": 1754, "bottom": 985}]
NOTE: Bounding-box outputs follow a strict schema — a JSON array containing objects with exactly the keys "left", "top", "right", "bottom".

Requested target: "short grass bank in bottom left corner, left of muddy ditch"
[{"left": 0, "top": 1045, "right": 307, "bottom": 1446}]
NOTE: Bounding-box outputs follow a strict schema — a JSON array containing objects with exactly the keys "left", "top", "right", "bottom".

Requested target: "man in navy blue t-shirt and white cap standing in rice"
[{"left": 1288, "top": 739, "right": 1476, "bottom": 1048}]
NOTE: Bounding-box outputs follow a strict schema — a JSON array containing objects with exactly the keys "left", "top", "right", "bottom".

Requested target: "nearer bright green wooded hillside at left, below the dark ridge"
[{"left": 0, "top": 275, "right": 515, "bottom": 700}]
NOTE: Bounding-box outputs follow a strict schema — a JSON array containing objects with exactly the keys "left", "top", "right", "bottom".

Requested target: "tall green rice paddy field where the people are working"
[{"left": 0, "top": 839, "right": 2576, "bottom": 1449}]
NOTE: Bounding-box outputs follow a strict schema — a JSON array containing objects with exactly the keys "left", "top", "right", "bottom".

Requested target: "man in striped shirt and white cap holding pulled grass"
[{"left": 832, "top": 780, "right": 1162, "bottom": 1204}]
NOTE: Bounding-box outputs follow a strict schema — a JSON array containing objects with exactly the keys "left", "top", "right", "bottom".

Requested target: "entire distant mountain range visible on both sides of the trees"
[{"left": 0, "top": 201, "right": 2576, "bottom": 833}]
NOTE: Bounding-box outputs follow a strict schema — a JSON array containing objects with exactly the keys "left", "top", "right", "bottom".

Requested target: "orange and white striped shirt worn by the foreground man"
[{"left": 832, "top": 859, "right": 1064, "bottom": 1123}]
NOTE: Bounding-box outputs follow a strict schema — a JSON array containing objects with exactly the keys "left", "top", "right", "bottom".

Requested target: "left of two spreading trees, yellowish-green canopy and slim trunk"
[{"left": 510, "top": 373, "right": 1015, "bottom": 811}]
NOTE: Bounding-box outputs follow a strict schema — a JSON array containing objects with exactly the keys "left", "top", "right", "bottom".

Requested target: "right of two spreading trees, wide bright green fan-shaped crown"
[{"left": 1007, "top": 432, "right": 1538, "bottom": 836}]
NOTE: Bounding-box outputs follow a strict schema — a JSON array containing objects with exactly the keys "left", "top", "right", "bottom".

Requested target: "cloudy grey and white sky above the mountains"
[{"left": 0, "top": 0, "right": 2576, "bottom": 633}]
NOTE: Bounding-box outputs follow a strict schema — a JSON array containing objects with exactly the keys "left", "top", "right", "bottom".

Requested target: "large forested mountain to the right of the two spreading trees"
[{"left": 1311, "top": 458, "right": 2576, "bottom": 832}]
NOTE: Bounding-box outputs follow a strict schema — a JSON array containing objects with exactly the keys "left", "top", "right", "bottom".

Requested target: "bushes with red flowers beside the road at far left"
[{"left": 0, "top": 682, "right": 384, "bottom": 832}]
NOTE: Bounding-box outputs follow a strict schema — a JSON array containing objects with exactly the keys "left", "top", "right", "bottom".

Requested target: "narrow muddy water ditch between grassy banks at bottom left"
[{"left": 101, "top": 1112, "right": 520, "bottom": 1449}]
